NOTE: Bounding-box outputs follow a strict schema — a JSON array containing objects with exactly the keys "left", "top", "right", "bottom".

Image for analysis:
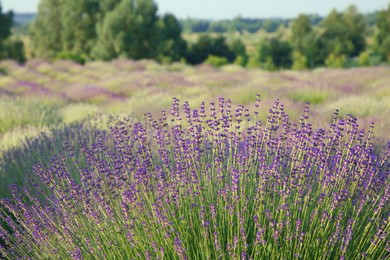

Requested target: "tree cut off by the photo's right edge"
[{"left": 375, "top": 4, "right": 390, "bottom": 61}]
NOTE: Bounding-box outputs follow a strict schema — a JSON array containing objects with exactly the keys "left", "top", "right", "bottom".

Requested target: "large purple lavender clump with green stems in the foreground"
[{"left": 0, "top": 96, "right": 390, "bottom": 259}]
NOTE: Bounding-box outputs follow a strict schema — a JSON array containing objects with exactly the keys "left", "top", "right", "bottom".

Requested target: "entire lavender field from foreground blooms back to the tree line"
[{"left": 0, "top": 60, "right": 390, "bottom": 259}]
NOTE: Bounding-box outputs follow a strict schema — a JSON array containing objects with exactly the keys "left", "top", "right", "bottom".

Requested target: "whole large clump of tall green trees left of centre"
[{"left": 30, "top": 0, "right": 186, "bottom": 63}]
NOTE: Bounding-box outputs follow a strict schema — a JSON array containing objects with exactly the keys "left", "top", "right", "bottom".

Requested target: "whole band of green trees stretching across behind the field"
[{"left": 0, "top": 0, "right": 390, "bottom": 70}]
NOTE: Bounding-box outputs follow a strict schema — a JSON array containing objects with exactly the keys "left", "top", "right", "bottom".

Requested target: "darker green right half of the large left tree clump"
[{"left": 93, "top": 0, "right": 186, "bottom": 62}]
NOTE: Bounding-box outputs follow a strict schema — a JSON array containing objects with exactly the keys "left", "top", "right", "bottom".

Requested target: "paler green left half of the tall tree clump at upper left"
[{"left": 29, "top": 0, "right": 108, "bottom": 59}]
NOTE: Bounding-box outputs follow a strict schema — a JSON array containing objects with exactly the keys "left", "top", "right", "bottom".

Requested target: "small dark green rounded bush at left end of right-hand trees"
[{"left": 259, "top": 37, "right": 292, "bottom": 70}]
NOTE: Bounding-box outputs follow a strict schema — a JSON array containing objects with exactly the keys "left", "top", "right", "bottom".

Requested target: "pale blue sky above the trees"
[{"left": 0, "top": 0, "right": 390, "bottom": 20}]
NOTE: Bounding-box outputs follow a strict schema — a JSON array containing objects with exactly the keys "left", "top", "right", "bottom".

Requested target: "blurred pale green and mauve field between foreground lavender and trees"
[{"left": 0, "top": 60, "right": 390, "bottom": 153}]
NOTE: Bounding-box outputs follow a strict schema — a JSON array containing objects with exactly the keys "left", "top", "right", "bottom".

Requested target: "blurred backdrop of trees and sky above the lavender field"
[{"left": 0, "top": 0, "right": 390, "bottom": 67}]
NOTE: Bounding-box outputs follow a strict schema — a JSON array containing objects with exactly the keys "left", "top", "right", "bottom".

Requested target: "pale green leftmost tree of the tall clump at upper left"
[{"left": 29, "top": 0, "right": 64, "bottom": 59}]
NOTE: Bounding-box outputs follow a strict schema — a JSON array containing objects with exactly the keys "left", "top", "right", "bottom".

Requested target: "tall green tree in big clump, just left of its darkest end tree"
[{"left": 92, "top": 0, "right": 162, "bottom": 60}]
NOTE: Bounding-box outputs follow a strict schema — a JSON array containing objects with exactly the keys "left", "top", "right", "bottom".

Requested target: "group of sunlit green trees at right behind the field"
[{"left": 259, "top": 5, "right": 390, "bottom": 70}]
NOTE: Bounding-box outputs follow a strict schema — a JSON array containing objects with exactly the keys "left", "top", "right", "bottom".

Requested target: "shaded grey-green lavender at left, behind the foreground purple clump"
[{"left": 0, "top": 116, "right": 112, "bottom": 198}]
